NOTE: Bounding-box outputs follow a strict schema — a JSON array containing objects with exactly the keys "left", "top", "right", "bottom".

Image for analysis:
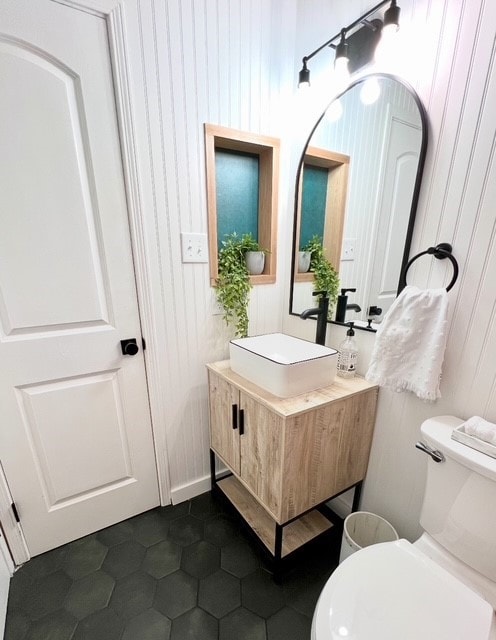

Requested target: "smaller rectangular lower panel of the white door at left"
[{"left": 18, "top": 372, "right": 135, "bottom": 511}]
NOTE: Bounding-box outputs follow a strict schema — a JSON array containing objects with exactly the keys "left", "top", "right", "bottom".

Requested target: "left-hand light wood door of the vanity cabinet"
[{"left": 208, "top": 371, "right": 239, "bottom": 474}]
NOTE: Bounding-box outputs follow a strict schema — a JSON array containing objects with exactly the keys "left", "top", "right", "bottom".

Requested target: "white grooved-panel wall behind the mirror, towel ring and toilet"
[{"left": 286, "top": 0, "right": 496, "bottom": 539}]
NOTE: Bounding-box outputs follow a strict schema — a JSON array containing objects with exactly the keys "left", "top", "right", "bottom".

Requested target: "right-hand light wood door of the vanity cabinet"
[{"left": 240, "top": 392, "right": 284, "bottom": 521}]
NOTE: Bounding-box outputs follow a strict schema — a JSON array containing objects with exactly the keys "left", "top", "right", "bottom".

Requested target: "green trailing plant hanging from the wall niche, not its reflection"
[{"left": 214, "top": 232, "right": 264, "bottom": 338}]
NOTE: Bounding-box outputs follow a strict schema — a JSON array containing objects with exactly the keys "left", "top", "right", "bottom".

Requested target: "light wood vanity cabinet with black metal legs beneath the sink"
[{"left": 207, "top": 360, "right": 377, "bottom": 567}]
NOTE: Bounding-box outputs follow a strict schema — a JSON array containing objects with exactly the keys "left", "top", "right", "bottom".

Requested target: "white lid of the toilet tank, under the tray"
[{"left": 420, "top": 416, "right": 496, "bottom": 481}]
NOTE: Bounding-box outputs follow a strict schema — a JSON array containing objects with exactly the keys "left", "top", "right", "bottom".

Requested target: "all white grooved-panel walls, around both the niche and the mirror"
[{"left": 124, "top": 0, "right": 496, "bottom": 538}]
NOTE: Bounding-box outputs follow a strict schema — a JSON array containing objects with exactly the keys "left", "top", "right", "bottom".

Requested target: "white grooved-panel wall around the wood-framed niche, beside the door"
[{"left": 123, "top": 0, "right": 296, "bottom": 502}]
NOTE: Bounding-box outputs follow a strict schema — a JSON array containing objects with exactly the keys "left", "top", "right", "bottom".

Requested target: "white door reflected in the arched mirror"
[{"left": 367, "top": 113, "right": 422, "bottom": 317}]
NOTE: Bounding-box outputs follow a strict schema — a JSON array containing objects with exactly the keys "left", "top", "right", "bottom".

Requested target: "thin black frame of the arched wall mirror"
[{"left": 289, "top": 73, "right": 429, "bottom": 332}]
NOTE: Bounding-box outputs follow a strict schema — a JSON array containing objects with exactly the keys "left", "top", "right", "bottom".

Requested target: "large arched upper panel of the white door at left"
[{"left": 0, "top": 42, "right": 108, "bottom": 335}]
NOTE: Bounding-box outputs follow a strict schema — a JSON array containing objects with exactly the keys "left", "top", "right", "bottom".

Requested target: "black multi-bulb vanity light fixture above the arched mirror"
[{"left": 298, "top": 0, "right": 400, "bottom": 87}]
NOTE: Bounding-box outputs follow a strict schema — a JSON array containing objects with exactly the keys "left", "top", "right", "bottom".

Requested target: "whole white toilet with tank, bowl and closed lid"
[{"left": 312, "top": 416, "right": 496, "bottom": 640}]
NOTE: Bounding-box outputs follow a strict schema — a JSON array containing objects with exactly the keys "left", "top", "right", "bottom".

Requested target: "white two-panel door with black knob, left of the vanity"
[{"left": 0, "top": 0, "right": 159, "bottom": 555}]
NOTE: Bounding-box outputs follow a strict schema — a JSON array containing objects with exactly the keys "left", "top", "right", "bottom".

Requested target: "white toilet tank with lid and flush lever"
[{"left": 420, "top": 416, "right": 496, "bottom": 582}]
